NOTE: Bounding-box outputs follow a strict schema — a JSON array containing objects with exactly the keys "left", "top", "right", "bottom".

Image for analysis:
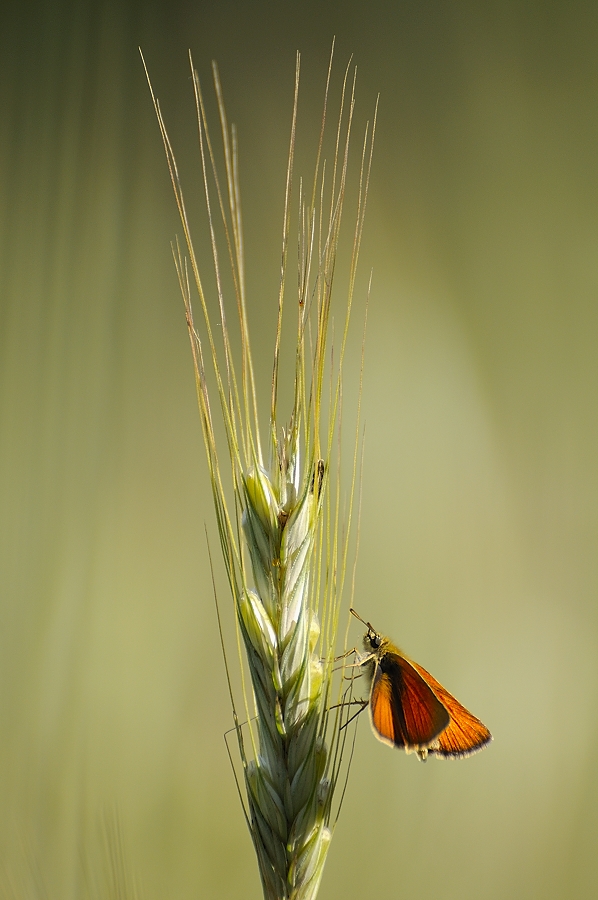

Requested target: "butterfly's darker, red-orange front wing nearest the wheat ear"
[{"left": 370, "top": 651, "right": 450, "bottom": 753}]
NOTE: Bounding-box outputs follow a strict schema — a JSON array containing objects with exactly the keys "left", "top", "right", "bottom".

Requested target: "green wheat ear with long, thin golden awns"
[{"left": 146, "top": 47, "right": 375, "bottom": 900}]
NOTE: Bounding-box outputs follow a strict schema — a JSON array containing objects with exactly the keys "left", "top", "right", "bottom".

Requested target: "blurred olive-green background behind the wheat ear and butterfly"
[{"left": 0, "top": 0, "right": 598, "bottom": 900}]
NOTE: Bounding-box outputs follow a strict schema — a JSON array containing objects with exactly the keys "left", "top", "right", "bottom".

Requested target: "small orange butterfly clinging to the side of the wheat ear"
[{"left": 351, "top": 609, "right": 492, "bottom": 759}]
